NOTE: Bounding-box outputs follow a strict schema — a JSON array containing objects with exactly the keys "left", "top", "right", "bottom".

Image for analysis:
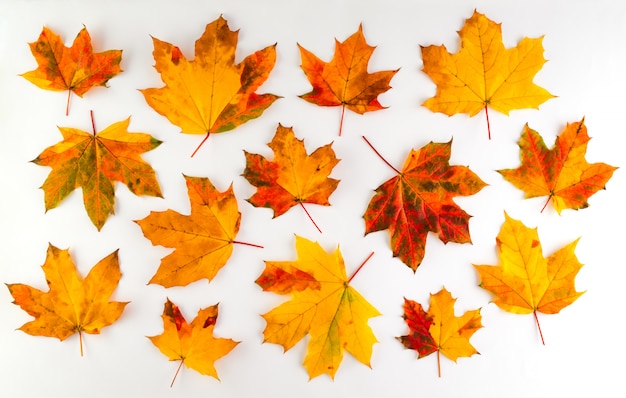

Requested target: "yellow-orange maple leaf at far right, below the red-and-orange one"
[{"left": 474, "top": 213, "right": 583, "bottom": 342}]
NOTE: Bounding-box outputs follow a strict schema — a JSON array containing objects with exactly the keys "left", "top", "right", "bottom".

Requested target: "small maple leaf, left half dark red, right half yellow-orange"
[{"left": 398, "top": 287, "right": 483, "bottom": 377}]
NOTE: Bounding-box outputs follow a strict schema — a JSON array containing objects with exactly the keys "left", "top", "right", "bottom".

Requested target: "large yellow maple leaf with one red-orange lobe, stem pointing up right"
[{"left": 256, "top": 236, "right": 380, "bottom": 379}]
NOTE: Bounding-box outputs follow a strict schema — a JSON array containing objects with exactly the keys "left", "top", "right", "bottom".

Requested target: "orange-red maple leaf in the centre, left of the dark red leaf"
[{"left": 243, "top": 124, "right": 339, "bottom": 232}]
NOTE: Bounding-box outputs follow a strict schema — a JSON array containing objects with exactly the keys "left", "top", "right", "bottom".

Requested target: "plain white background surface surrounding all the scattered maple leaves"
[{"left": 0, "top": 0, "right": 626, "bottom": 397}]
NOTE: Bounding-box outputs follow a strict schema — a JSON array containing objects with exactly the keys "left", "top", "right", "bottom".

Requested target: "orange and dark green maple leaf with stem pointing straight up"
[{"left": 33, "top": 114, "right": 162, "bottom": 230}]
